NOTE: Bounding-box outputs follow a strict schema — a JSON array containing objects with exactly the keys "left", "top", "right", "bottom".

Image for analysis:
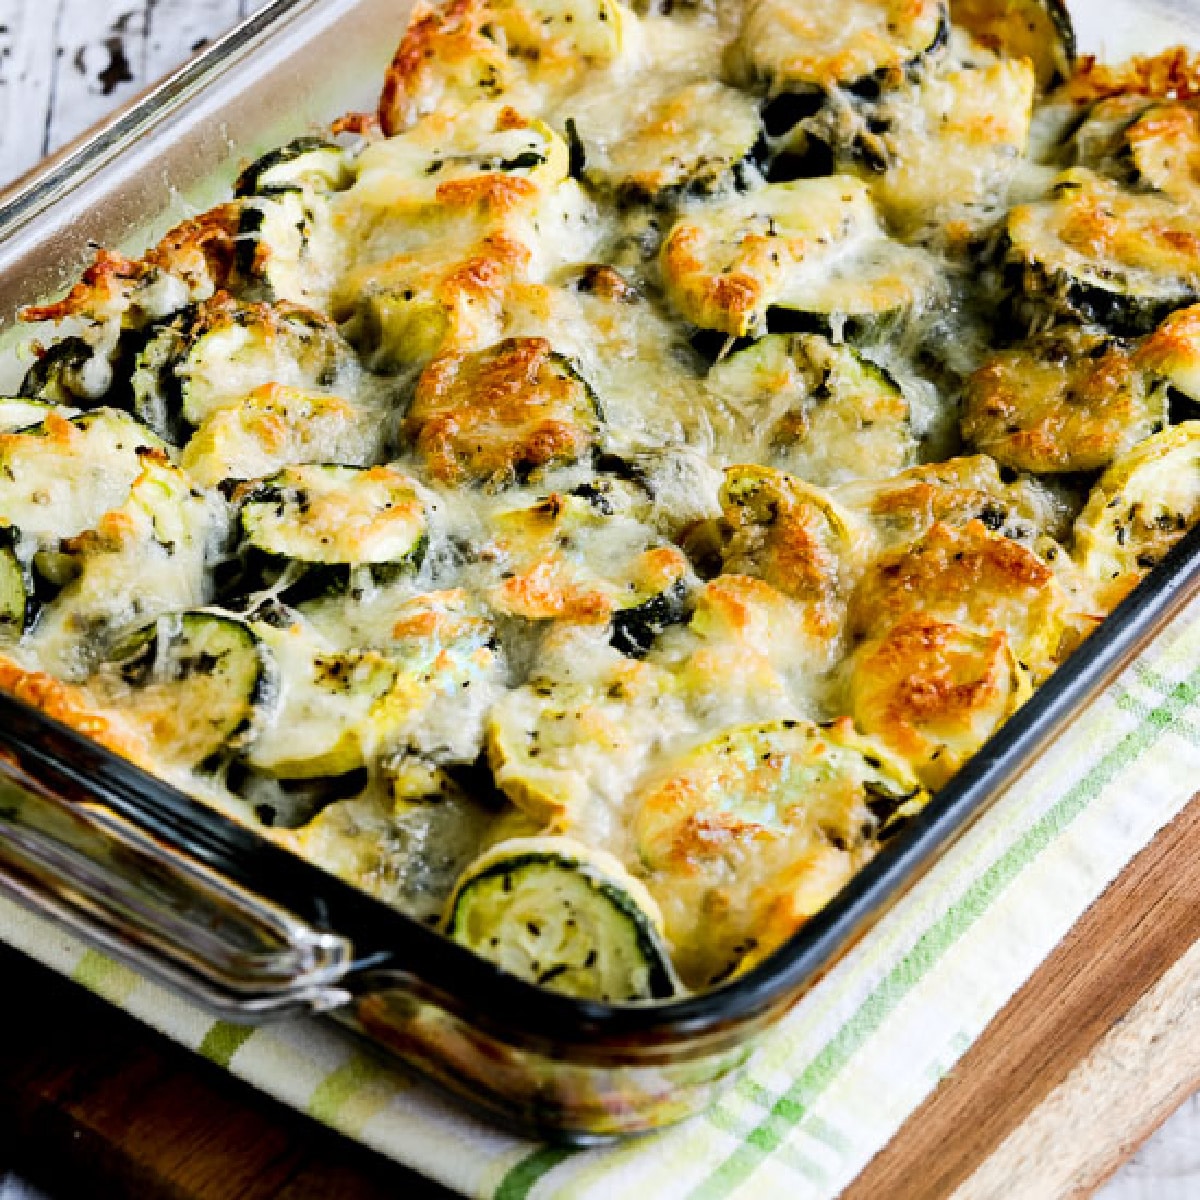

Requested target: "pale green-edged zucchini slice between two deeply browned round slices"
[{"left": 708, "top": 334, "right": 917, "bottom": 487}]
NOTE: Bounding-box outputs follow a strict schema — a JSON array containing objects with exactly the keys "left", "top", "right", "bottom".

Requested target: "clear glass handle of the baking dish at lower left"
[{"left": 0, "top": 750, "right": 353, "bottom": 1021}]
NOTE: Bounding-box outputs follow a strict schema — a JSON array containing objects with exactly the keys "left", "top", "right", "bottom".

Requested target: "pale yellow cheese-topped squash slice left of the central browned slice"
[{"left": 181, "top": 383, "right": 385, "bottom": 487}]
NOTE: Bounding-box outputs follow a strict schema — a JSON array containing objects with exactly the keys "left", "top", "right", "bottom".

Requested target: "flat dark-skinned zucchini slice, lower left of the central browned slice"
[{"left": 236, "top": 464, "right": 428, "bottom": 594}]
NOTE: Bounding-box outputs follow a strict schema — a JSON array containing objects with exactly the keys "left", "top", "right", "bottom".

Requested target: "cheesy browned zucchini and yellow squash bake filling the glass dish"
[{"left": 7, "top": 0, "right": 1200, "bottom": 1001}]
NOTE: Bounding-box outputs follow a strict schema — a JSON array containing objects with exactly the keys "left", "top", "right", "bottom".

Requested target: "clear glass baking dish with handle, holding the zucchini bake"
[{"left": 0, "top": 0, "right": 1200, "bottom": 1141}]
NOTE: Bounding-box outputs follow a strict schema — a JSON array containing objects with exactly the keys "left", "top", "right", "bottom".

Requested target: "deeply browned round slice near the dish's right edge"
[{"left": 962, "top": 329, "right": 1168, "bottom": 474}]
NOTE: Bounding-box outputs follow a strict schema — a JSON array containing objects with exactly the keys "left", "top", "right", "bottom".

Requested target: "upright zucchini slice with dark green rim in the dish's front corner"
[{"left": 445, "top": 838, "right": 679, "bottom": 1003}]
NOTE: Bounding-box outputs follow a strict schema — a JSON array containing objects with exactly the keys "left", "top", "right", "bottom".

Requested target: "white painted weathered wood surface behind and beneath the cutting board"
[{"left": 0, "top": 0, "right": 1200, "bottom": 1200}]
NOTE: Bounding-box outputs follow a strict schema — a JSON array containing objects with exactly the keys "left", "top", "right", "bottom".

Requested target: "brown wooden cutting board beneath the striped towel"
[{"left": 0, "top": 799, "right": 1200, "bottom": 1200}]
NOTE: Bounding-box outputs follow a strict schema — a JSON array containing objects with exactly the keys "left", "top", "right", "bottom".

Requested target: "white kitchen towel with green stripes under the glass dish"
[{"left": 7, "top": 592, "right": 1200, "bottom": 1200}]
